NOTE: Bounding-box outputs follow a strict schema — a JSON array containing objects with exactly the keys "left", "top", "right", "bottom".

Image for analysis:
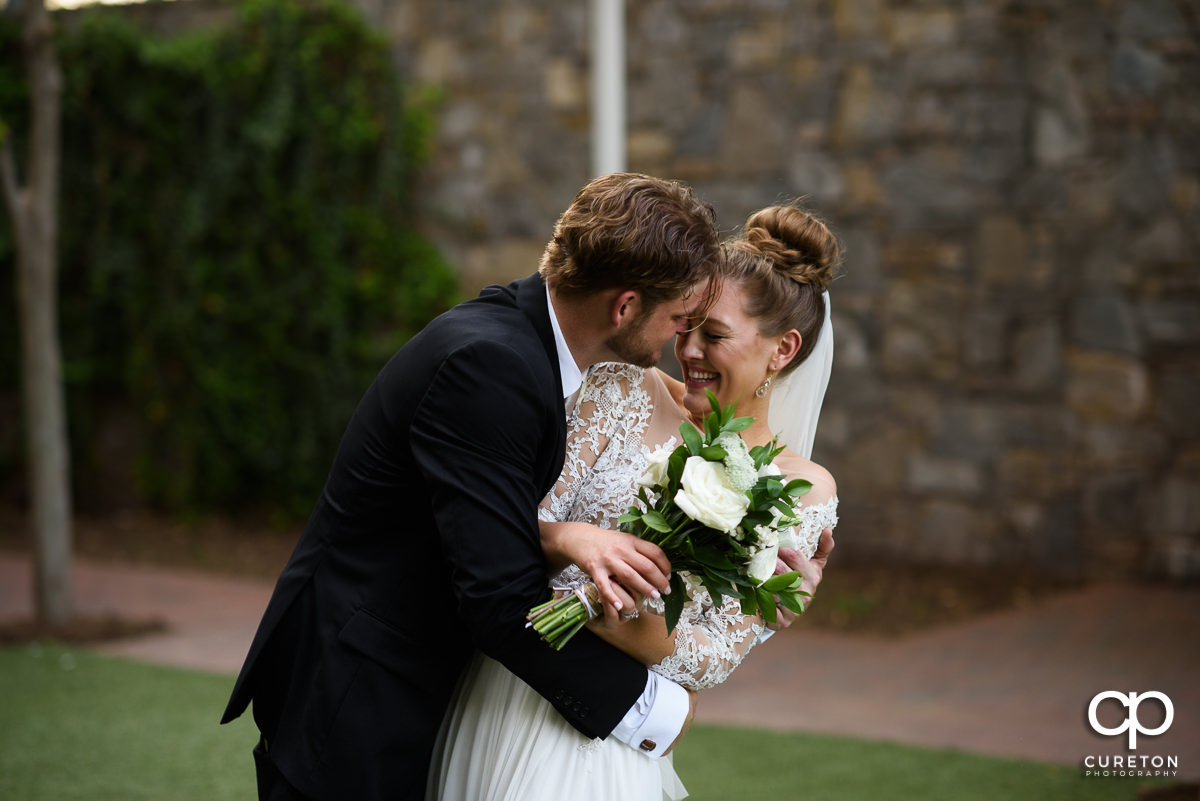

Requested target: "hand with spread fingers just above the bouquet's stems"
[{"left": 539, "top": 522, "right": 671, "bottom": 625}]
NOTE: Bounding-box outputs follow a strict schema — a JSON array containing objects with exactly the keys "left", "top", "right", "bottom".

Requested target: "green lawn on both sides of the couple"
[{"left": 0, "top": 646, "right": 1171, "bottom": 801}]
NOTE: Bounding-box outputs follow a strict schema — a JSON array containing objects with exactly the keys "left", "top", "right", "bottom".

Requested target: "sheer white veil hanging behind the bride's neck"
[{"left": 767, "top": 291, "right": 833, "bottom": 458}]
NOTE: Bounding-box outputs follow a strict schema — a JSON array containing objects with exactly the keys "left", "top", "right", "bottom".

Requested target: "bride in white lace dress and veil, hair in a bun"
[{"left": 427, "top": 206, "right": 839, "bottom": 801}]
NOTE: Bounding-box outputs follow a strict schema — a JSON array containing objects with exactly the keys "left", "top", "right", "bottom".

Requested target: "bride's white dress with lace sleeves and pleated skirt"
[{"left": 427, "top": 365, "right": 838, "bottom": 801}]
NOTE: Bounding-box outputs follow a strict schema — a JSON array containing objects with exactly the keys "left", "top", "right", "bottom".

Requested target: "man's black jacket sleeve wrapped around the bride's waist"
[{"left": 410, "top": 343, "right": 646, "bottom": 737}]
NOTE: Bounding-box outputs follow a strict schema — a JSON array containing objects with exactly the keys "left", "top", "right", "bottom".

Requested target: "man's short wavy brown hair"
[{"left": 539, "top": 173, "right": 720, "bottom": 309}]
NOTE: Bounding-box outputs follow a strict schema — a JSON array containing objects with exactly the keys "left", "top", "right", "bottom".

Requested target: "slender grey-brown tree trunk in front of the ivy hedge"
[{"left": 0, "top": 0, "right": 73, "bottom": 626}]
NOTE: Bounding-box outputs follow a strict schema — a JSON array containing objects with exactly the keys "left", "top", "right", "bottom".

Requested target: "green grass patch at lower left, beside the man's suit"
[{"left": 0, "top": 646, "right": 257, "bottom": 801}]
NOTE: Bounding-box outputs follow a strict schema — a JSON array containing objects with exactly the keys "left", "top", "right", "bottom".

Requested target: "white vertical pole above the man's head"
[{"left": 592, "top": 0, "right": 625, "bottom": 175}]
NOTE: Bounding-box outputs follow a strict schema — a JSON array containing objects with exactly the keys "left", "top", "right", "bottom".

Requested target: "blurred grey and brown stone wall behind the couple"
[{"left": 105, "top": 0, "right": 1200, "bottom": 578}]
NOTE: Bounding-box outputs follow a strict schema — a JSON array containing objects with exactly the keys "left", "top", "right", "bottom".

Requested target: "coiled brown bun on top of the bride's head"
[{"left": 745, "top": 206, "right": 839, "bottom": 291}]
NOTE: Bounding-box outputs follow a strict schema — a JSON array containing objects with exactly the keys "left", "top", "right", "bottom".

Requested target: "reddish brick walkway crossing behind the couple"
[{"left": 0, "top": 555, "right": 1200, "bottom": 779}]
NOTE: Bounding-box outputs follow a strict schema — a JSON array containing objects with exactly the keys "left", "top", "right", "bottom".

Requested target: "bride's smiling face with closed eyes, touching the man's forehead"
[{"left": 674, "top": 282, "right": 780, "bottom": 418}]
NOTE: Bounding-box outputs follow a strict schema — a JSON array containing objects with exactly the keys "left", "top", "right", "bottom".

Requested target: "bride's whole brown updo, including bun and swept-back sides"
[{"left": 721, "top": 201, "right": 841, "bottom": 374}]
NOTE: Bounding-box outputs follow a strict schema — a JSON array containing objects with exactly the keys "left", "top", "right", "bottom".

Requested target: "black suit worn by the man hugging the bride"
[{"left": 222, "top": 276, "right": 646, "bottom": 801}]
